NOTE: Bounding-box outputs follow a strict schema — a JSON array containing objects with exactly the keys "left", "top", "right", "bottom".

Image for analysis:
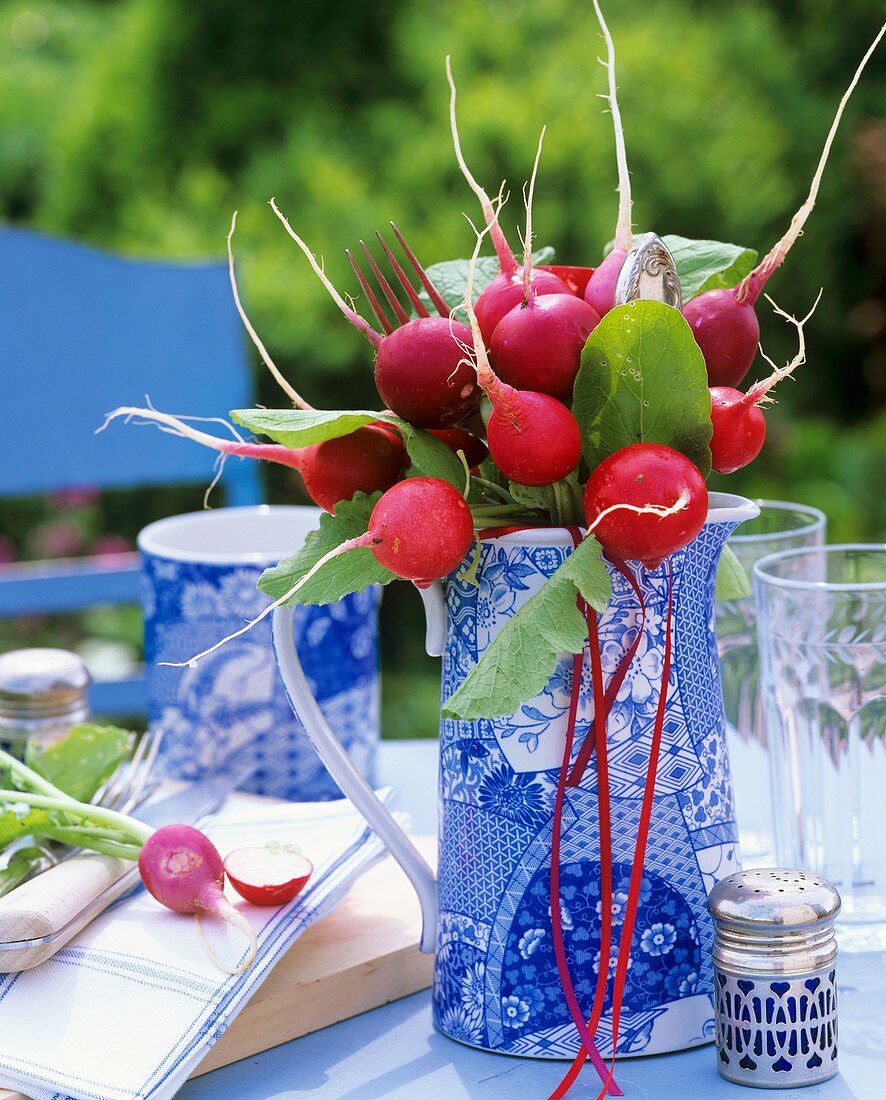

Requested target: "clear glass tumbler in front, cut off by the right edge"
[{"left": 754, "top": 545, "right": 886, "bottom": 950}]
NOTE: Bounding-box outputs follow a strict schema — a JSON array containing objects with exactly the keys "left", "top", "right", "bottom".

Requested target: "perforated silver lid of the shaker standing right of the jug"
[{"left": 708, "top": 867, "right": 841, "bottom": 935}]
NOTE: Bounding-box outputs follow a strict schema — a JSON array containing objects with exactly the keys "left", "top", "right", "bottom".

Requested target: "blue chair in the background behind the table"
[{"left": 0, "top": 227, "right": 262, "bottom": 714}]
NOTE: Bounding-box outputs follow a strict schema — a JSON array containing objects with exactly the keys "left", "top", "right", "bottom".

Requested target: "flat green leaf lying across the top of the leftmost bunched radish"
[{"left": 231, "top": 409, "right": 464, "bottom": 488}]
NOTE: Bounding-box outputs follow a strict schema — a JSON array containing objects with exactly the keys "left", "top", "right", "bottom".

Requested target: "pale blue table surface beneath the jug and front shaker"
[{"left": 178, "top": 741, "right": 886, "bottom": 1100}]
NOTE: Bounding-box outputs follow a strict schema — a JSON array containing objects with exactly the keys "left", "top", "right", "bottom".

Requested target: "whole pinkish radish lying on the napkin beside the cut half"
[{"left": 139, "top": 825, "right": 256, "bottom": 974}]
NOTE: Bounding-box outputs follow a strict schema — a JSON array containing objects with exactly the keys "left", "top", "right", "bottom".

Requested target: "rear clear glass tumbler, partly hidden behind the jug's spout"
[{"left": 717, "top": 501, "right": 827, "bottom": 868}]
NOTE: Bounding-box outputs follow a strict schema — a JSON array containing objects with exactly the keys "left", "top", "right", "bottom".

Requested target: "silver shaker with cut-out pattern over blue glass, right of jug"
[{"left": 708, "top": 868, "right": 840, "bottom": 1089}]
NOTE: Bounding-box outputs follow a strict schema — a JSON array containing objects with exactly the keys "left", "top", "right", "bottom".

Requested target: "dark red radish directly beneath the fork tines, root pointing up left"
[{"left": 271, "top": 199, "right": 481, "bottom": 428}]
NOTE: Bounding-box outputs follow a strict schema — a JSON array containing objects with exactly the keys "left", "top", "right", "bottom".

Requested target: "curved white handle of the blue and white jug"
[{"left": 271, "top": 607, "right": 437, "bottom": 952}]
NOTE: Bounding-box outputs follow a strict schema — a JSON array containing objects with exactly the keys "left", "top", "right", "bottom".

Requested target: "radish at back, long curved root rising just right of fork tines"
[{"left": 446, "top": 57, "right": 569, "bottom": 344}]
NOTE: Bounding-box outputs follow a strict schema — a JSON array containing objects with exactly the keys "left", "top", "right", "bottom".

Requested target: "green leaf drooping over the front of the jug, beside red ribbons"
[{"left": 442, "top": 537, "right": 612, "bottom": 719}]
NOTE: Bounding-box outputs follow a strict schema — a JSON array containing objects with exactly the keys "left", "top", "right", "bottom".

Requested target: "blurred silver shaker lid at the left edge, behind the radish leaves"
[{"left": 0, "top": 649, "right": 92, "bottom": 722}]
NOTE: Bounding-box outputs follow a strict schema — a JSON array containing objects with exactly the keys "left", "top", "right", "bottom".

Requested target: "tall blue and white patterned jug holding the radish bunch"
[{"left": 274, "top": 493, "right": 758, "bottom": 1058}]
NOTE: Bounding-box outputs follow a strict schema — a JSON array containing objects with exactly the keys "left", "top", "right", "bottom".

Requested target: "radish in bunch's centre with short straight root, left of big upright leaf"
[{"left": 484, "top": 129, "right": 600, "bottom": 400}]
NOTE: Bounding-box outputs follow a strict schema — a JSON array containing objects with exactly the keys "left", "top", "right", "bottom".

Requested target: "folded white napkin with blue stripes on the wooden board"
[{"left": 0, "top": 795, "right": 398, "bottom": 1100}]
